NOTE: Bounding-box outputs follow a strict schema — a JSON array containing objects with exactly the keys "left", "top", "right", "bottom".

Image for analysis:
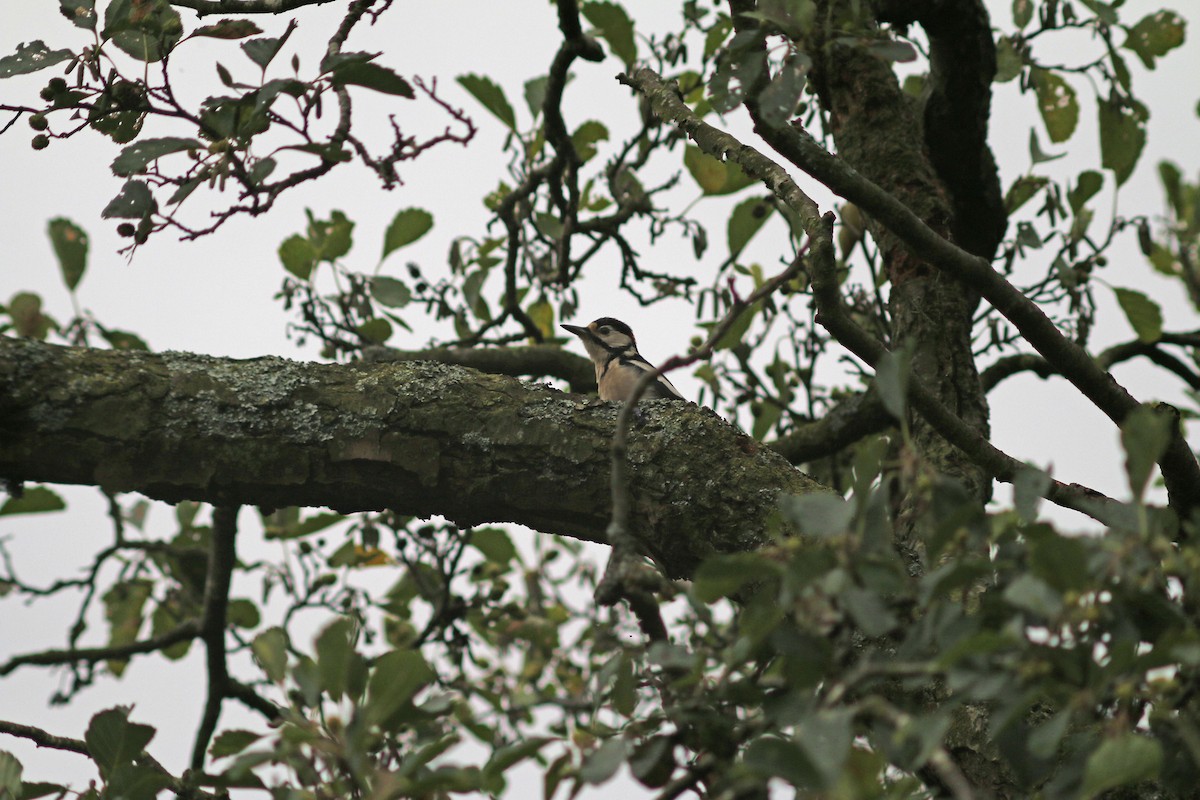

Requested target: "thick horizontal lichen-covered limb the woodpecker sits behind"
[{"left": 0, "top": 337, "right": 818, "bottom": 576}]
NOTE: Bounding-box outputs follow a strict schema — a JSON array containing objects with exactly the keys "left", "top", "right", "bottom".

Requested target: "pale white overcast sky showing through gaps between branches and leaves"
[{"left": 0, "top": 0, "right": 1200, "bottom": 796}]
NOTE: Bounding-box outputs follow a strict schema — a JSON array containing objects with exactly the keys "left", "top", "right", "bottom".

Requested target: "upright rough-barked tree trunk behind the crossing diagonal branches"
[{"left": 814, "top": 0, "right": 1002, "bottom": 500}]
